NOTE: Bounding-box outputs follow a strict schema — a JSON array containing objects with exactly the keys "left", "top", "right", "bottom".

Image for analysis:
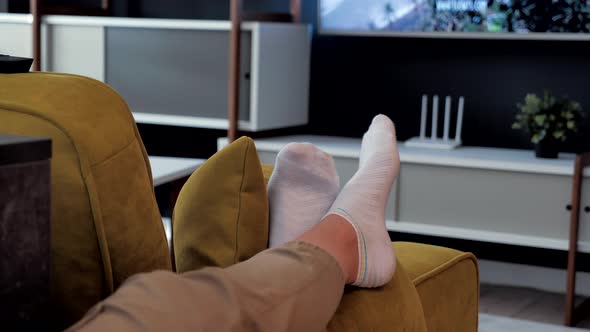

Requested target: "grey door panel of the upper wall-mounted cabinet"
[{"left": 106, "top": 27, "right": 252, "bottom": 120}]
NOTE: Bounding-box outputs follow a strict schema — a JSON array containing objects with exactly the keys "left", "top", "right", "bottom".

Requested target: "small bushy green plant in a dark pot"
[{"left": 512, "top": 90, "right": 584, "bottom": 158}]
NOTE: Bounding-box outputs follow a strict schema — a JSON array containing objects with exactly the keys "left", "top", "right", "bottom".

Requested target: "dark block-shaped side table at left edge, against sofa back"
[{"left": 0, "top": 134, "right": 51, "bottom": 331}]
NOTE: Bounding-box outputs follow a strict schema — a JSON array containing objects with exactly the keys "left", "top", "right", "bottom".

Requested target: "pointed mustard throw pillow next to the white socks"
[{"left": 173, "top": 137, "right": 268, "bottom": 272}]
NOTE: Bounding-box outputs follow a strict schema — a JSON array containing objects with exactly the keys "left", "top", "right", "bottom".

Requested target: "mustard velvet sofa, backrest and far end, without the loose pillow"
[{"left": 0, "top": 73, "right": 479, "bottom": 332}]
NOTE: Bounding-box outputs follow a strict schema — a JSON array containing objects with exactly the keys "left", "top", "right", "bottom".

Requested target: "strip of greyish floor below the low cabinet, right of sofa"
[{"left": 479, "top": 284, "right": 590, "bottom": 329}]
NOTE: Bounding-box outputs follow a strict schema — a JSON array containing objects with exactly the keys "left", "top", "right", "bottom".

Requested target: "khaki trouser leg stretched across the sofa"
[{"left": 68, "top": 242, "right": 345, "bottom": 332}]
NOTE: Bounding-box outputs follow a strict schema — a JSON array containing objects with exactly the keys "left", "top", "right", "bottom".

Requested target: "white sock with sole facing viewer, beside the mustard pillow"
[{"left": 267, "top": 143, "right": 340, "bottom": 248}]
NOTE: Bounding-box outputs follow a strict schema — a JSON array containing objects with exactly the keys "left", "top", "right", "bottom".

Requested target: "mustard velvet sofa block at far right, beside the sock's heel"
[{"left": 394, "top": 242, "right": 479, "bottom": 332}]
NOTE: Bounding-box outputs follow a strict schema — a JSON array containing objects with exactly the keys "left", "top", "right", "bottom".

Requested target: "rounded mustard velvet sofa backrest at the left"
[{"left": 0, "top": 73, "right": 171, "bottom": 330}]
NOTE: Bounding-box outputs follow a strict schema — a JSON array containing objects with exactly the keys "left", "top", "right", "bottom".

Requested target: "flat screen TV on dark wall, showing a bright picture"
[{"left": 319, "top": 0, "right": 590, "bottom": 39}]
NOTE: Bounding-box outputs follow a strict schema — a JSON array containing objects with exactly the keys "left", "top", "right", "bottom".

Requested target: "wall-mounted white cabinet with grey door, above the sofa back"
[{"left": 0, "top": 13, "right": 311, "bottom": 131}]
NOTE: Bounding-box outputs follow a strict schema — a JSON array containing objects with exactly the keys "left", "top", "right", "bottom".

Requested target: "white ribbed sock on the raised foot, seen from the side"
[{"left": 328, "top": 115, "right": 399, "bottom": 287}]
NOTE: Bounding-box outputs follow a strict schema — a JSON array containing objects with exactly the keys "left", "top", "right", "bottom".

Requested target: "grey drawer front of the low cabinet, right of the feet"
[{"left": 399, "top": 163, "right": 571, "bottom": 239}]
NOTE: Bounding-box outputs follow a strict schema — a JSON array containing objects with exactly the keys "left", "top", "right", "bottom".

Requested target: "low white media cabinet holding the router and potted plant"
[{"left": 218, "top": 136, "right": 590, "bottom": 253}]
